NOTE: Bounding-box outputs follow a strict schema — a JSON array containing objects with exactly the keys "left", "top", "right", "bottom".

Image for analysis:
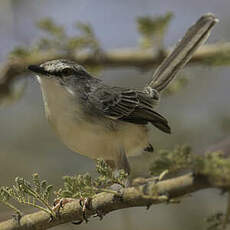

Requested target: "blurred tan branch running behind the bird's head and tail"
[{"left": 0, "top": 42, "right": 230, "bottom": 97}]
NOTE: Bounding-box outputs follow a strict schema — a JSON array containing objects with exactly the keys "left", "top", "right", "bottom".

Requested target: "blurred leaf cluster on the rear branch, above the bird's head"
[{"left": 10, "top": 18, "right": 101, "bottom": 58}]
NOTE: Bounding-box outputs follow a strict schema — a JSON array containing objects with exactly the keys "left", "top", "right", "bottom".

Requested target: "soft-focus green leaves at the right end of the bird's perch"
[{"left": 150, "top": 146, "right": 230, "bottom": 188}]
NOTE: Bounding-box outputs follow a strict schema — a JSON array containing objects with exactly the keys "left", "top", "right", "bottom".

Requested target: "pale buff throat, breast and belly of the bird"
[{"left": 37, "top": 78, "right": 148, "bottom": 160}]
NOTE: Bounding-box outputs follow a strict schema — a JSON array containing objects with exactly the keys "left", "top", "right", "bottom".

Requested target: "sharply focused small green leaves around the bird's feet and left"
[{"left": 0, "top": 159, "right": 128, "bottom": 217}]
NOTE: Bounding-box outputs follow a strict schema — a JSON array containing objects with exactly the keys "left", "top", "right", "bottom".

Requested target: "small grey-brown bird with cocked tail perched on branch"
[{"left": 28, "top": 14, "right": 217, "bottom": 176}]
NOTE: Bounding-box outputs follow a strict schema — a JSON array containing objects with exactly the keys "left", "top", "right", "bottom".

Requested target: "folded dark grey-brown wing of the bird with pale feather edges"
[{"left": 88, "top": 85, "right": 170, "bottom": 133}]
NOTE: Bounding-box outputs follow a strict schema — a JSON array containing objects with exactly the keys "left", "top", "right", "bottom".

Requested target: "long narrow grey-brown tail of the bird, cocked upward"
[{"left": 145, "top": 13, "right": 219, "bottom": 92}]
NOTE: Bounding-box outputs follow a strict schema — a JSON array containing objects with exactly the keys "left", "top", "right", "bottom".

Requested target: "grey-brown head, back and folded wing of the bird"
[{"left": 29, "top": 60, "right": 170, "bottom": 133}]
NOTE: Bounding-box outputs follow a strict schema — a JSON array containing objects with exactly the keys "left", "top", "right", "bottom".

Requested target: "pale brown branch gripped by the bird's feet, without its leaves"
[{"left": 0, "top": 173, "right": 212, "bottom": 230}]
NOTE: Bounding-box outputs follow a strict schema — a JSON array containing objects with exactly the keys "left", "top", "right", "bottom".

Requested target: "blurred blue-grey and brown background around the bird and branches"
[{"left": 0, "top": 0, "right": 230, "bottom": 230}]
